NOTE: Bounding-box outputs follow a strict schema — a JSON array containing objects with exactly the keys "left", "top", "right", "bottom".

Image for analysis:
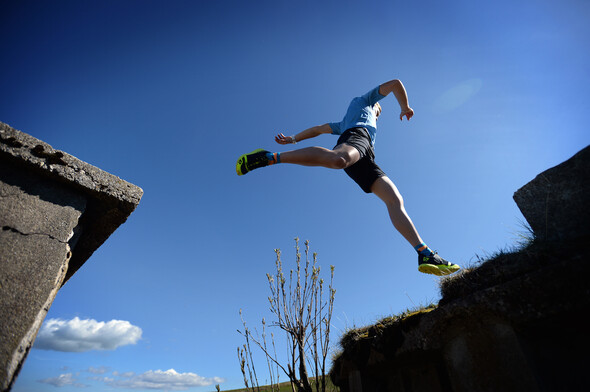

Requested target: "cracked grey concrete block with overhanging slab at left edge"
[{"left": 0, "top": 122, "right": 143, "bottom": 391}]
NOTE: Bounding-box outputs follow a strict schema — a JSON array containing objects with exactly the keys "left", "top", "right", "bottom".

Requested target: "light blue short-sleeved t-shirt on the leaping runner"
[{"left": 328, "top": 86, "right": 385, "bottom": 146}]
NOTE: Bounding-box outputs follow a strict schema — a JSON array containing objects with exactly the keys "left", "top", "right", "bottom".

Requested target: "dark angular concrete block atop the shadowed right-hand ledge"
[{"left": 514, "top": 146, "right": 590, "bottom": 241}]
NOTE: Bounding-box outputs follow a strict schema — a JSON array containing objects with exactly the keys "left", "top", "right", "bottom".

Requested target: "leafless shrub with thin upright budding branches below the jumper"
[{"left": 238, "top": 238, "right": 336, "bottom": 392}]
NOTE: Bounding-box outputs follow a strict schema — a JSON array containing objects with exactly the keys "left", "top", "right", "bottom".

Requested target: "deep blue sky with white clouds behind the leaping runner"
[{"left": 0, "top": 0, "right": 590, "bottom": 392}]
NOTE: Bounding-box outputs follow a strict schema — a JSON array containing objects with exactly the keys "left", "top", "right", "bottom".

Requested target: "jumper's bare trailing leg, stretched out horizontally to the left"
[{"left": 281, "top": 144, "right": 360, "bottom": 169}]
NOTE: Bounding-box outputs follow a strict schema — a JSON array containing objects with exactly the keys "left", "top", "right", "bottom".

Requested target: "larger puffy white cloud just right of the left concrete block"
[{"left": 34, "top": 317, "right": 142, "bottom": 352}]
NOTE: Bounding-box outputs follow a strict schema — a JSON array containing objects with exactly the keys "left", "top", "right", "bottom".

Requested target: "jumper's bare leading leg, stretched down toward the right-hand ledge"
[{"left": 371, "top": 176, "right": 422, "bottom": 246}]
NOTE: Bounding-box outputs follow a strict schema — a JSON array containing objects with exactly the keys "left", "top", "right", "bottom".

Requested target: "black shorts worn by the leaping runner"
[{"left": 334, "top": 128, "right": 385, "bottom": 193}]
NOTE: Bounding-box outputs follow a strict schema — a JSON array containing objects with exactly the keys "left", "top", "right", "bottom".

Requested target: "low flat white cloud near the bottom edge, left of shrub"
[{"left": 105, "top": 369, "right": 224, "bottom": 391}]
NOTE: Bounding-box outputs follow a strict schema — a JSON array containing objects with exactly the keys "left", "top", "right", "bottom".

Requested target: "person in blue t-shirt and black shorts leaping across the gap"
[{"left": 236, "top": 79, "right": 460, "bottom": 276}]
